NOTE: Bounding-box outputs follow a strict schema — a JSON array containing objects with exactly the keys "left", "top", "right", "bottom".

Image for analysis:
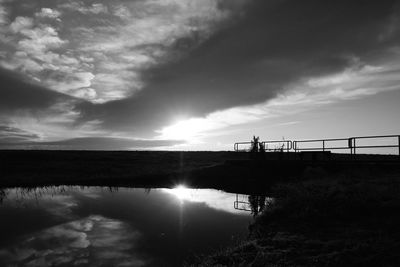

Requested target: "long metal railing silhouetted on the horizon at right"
[{"left": 234, "top": 135, "right": 400, "bottom": 156}]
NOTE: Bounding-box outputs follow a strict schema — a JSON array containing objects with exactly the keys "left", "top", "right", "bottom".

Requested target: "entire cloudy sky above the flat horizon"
[{"left": 0, "top": 0, "right": 400, "bottom": 150}]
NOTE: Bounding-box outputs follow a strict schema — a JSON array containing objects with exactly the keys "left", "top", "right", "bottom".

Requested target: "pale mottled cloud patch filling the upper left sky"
[{"left": 0, "top": 0, "right": 245, "bottom": 103}]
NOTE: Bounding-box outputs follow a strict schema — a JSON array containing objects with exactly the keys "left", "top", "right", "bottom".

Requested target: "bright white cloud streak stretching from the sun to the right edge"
[{"left": 157, "top": 58, "right": 400, "bottom": 142}]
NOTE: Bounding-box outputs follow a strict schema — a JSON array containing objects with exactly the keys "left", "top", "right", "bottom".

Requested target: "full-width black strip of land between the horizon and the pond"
[{"left": 0, "top": 150, "right": 400, "bottom": 193}]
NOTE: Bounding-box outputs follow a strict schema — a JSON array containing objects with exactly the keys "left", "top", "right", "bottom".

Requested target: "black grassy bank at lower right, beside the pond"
[{"left": 191, "top": 170, "right": 400, "bottom": 266}]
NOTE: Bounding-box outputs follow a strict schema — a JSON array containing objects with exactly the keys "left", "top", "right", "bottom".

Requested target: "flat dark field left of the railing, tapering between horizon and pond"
[{"left": 0, "top": 150, "right": 247, "bottom": 187}]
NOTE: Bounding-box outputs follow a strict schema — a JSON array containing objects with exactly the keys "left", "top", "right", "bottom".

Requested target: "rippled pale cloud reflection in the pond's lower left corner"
[{"left": 0, "top": 215, "right": 146, "bottom": 266}]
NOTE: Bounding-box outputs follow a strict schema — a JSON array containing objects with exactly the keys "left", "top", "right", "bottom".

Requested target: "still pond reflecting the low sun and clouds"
[{"left": 0, "top": 187, "right": 253, "bottom": 266}]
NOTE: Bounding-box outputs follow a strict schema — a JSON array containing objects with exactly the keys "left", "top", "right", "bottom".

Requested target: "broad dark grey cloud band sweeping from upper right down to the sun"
[{"left": 77, "top": 1, "right": 398, "bottom": 136}]
